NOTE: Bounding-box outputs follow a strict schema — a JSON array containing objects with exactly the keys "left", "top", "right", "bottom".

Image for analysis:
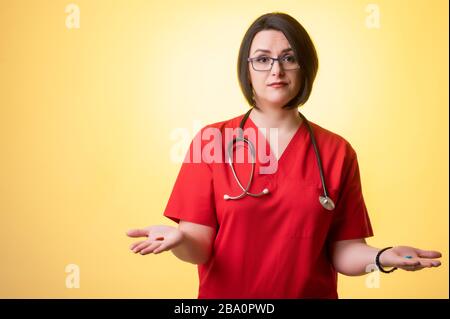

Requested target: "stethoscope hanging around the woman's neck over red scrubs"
[{"left": 223, "top": 108, "right": 335, "bottom": 210}]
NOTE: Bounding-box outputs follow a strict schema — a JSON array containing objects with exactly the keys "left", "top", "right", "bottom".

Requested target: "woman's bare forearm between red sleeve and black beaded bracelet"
[{"left": 332, "top": 240, "right": 380, "bottom": 276}]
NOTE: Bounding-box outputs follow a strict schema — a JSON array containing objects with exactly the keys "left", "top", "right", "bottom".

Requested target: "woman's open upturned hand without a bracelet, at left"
[{"left": 127, "top": 225, "right": 183, "bottom": 255}]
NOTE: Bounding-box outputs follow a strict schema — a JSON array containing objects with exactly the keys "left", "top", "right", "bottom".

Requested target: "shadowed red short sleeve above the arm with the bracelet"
[{"left": 328, "top": 146, "right": 373, "bottom": 242}]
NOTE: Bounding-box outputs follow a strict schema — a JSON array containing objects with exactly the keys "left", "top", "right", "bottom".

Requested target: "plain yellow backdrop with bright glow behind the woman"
[{"left": 0, "top": 0, "right": 449, "bottom": 298}]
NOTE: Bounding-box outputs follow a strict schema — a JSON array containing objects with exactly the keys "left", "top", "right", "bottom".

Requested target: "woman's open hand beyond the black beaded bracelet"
[{"left": 380, "top": 246, "right": 442, "bottom": 271}]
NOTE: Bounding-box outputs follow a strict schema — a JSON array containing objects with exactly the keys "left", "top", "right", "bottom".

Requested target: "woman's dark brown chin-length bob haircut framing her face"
[{"left": 237, "top": 12, "right": 319, "bottom": 109}]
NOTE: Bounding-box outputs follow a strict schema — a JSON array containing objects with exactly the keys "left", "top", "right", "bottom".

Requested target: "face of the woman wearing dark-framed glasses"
[{"left": 248, "top": 30, "right": 301, "bottom": 108}]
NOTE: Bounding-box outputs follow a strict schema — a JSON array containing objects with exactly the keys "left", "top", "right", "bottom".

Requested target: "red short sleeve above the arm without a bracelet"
[{"left": 163, "top": 130, "right": 217, "bottom": 228}]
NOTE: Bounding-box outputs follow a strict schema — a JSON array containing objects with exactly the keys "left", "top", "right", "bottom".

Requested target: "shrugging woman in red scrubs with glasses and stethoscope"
[{"left": 127, "top": 13, "right": 441, "bottom": 298}]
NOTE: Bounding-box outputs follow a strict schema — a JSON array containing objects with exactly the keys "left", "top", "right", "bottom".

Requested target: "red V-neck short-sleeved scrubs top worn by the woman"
[{"left": 164, "top": 115, "right": 373, "bottom": 298}]
